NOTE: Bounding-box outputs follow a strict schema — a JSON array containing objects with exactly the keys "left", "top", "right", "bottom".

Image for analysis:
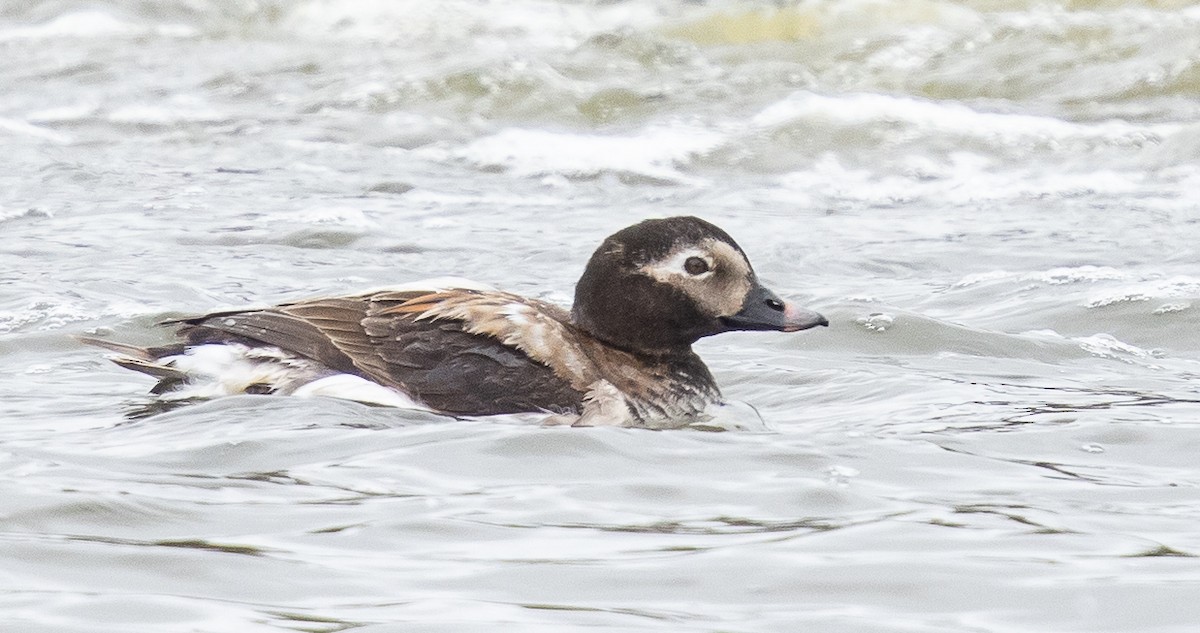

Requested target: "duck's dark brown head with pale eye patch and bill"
[{"left": 571, "top": 217, "right": 828, "bottom": 354}]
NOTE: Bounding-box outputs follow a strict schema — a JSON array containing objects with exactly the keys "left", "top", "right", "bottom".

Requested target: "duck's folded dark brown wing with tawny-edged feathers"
[{"left": 165, "top": 290, "right": 583, "bottom": 415}]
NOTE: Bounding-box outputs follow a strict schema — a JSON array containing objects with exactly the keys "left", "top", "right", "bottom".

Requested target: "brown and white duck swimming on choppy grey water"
[{"left": 84, "top": 216, "right": 829, "bottom": 427}]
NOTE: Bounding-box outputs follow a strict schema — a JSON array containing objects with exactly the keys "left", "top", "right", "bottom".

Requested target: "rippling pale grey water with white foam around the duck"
[{"left": 0, "top": 0, "right": 1200, "bottom": 633}]
